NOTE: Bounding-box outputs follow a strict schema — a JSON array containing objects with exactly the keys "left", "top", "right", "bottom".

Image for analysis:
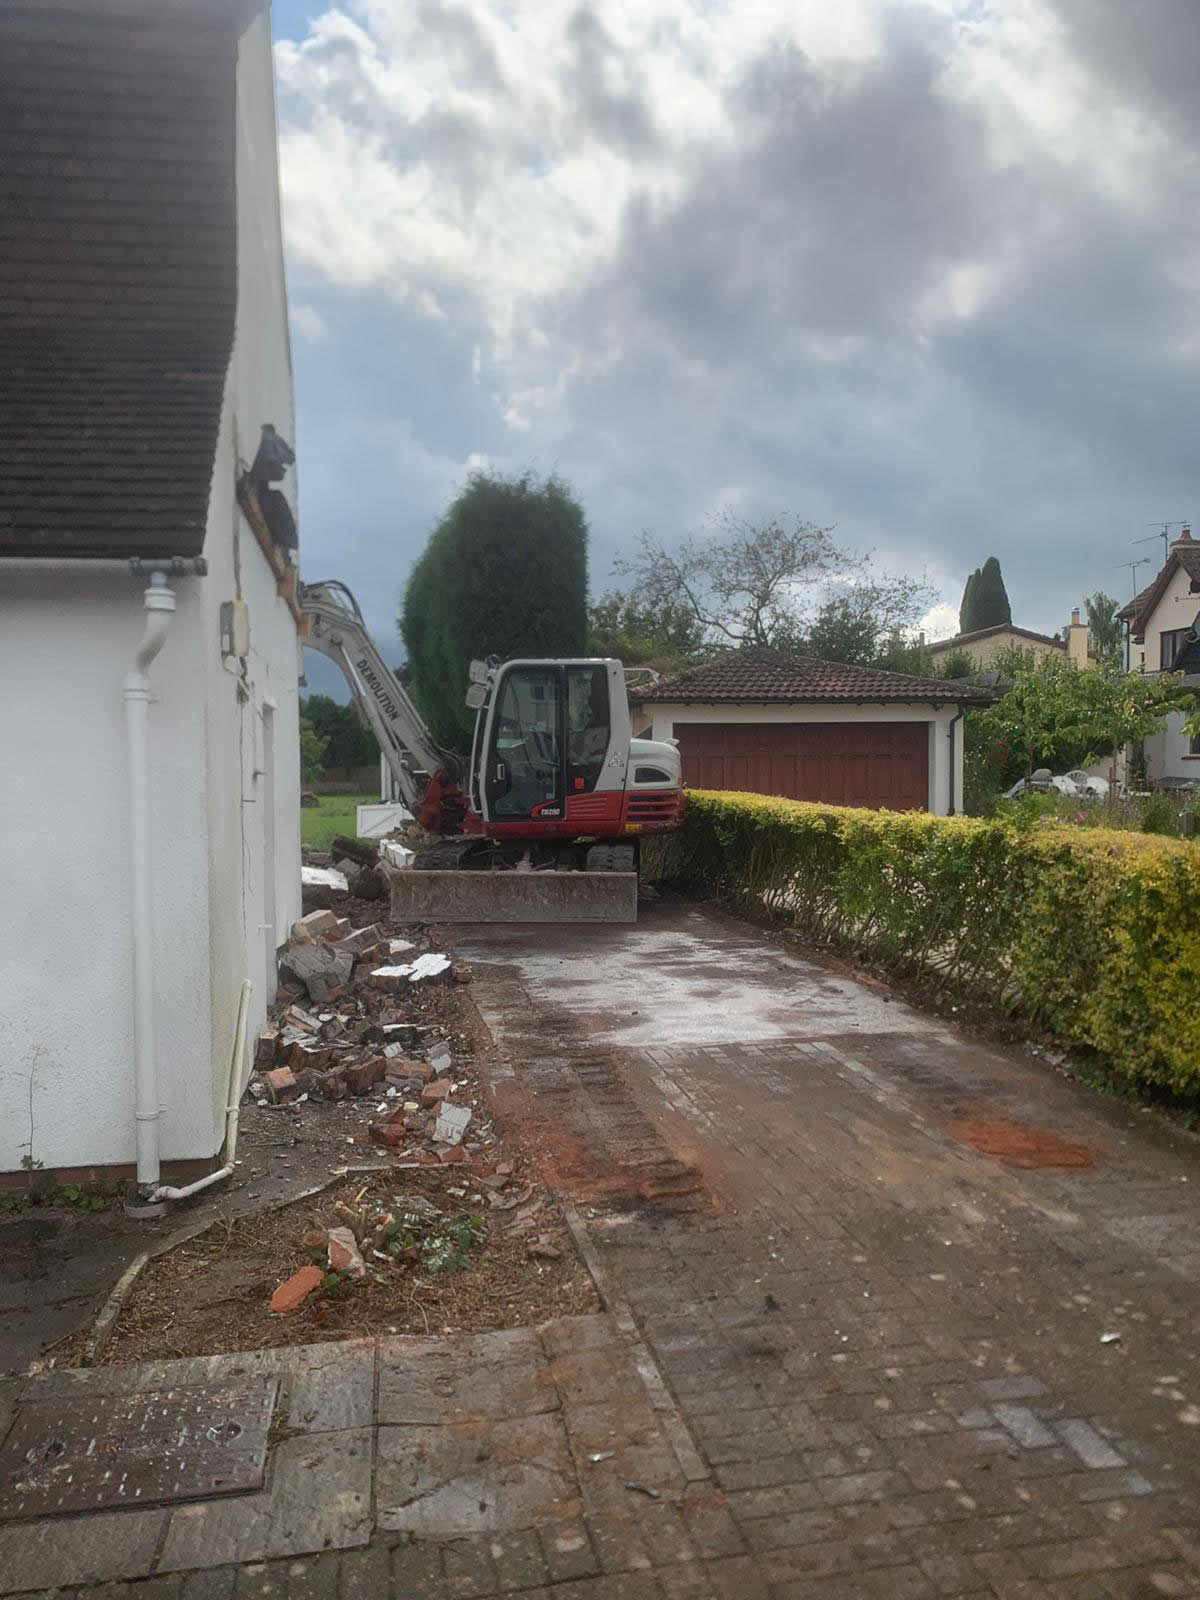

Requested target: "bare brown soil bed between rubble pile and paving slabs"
[{"left": 59, "top": 1168, "right": 600, "bottom": 1366}]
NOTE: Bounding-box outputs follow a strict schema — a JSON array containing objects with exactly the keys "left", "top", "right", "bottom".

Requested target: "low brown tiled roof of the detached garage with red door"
[{"left": 637, "top": 646, "right": 995, "bottom": 706}]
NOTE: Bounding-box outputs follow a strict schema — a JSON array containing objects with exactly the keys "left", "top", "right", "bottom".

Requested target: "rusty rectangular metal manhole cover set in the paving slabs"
[{"left": 0, "top": 1378, "right": 278, "bottom": 1518}]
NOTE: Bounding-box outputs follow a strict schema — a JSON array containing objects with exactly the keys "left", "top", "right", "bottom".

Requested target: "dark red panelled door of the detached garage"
[{"left": 675, "top": 722, "right": 930, "bottom": 811}]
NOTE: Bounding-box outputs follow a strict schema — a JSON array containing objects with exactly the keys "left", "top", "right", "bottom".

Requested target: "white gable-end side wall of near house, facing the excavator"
[{"left": 203, "top": 3, "right": 301, "bottom": 1126}]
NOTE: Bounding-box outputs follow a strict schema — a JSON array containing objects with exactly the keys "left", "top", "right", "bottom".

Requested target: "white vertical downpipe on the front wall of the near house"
[{"left": 125, "top": 573, "right": 174, "bottom": 1195}]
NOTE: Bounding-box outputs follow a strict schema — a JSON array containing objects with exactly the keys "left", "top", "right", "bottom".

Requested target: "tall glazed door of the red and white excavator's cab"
[{"left": 486, "top": 667, "right": 562, "bottom": 819}]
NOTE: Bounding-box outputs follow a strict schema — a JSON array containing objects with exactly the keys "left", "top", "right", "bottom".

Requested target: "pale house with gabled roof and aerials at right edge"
[{"left": 1117, "top": 528, "right": 1200, "bottom": 787}]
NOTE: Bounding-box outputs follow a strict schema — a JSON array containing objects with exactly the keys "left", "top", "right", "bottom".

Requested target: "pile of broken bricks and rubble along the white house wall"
[{"left": 250, "top": 909, "right": 483, "bottom": 1165}]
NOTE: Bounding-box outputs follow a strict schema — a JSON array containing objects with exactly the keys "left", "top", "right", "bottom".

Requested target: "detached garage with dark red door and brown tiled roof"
[{"left": 634, "top": 648, "right": 995, "bottom": 816}]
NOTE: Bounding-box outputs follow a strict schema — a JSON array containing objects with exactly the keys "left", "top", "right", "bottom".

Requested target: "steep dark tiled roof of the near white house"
[{"left": 0, "top": 0, "right": 243, "bottom": 555}]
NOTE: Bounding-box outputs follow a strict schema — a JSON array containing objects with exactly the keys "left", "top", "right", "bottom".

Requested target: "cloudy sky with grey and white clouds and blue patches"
[{"left": 275, "top": 0, "right": 1200, "bottom": 694}]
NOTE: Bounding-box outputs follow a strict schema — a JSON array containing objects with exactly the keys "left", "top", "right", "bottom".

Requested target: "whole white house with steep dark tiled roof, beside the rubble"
[{"left": 0, "top": 0, "right": 301, "bottom": 1198}]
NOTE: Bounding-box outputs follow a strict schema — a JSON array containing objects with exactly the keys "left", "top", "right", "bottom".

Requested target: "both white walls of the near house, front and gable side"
[{"left": 0, "top": 6, "right": 301, "bottom": 1171}]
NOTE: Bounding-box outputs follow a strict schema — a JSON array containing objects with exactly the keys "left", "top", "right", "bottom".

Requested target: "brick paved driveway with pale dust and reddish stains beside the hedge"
[{"left": 9, "top": 902, "right": 1200, "bottom": 1600}]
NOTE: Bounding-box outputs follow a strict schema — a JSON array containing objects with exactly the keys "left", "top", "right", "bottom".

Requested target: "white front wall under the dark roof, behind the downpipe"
[{"left": 0, "top": 562, "right": 213, "bottom": 1171}]
